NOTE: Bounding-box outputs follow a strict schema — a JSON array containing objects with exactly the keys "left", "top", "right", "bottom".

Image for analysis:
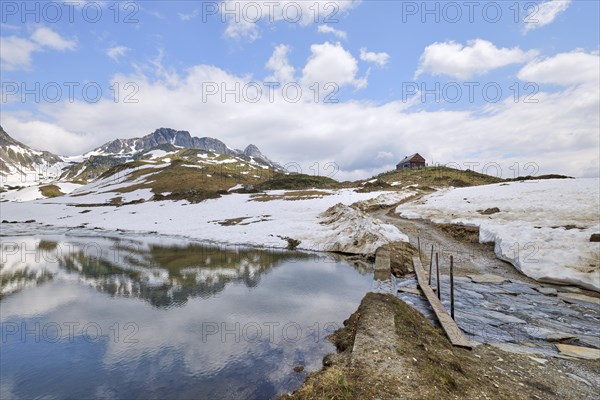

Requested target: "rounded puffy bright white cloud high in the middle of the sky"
[{"left": 302, "top": 42, "right": 367, "bottom": 89}]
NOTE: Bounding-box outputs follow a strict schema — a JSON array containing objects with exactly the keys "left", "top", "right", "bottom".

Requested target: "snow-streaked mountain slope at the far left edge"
[{"left": 0, "top": 126, "right": 65, "bottom": 191}]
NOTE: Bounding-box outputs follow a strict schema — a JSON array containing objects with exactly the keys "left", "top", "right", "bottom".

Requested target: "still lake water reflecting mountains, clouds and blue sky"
[{"left": 0, "top": 232, "right": 373, "bottom": 400}]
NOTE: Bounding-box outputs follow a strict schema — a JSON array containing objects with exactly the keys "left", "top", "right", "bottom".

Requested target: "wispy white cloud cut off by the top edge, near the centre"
[{"left": 219, "top": 0, "right": 362, "bottom": 42}]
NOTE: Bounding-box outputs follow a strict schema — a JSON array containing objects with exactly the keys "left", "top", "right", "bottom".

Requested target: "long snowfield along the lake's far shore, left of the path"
[{"left": 0, "top": 188, "right": 408, "bottom": 254}]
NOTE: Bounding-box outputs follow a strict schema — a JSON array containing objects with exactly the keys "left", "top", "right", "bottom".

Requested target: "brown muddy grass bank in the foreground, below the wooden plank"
[{"left": 281, "top": 293, "right": 600, "bottom": 400}]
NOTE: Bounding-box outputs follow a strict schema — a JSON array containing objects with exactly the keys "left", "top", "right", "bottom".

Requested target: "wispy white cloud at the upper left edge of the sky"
[{"left": 0, "top": 27, "right": 77, "bottom": 71}]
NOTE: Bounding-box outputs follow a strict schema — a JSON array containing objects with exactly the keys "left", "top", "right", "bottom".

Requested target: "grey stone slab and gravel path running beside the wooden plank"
[{"left": 373, "top": 210, "right": 600, "bottom": 357}]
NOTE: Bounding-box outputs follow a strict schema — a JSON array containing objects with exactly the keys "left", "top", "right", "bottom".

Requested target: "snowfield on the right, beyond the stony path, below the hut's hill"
[{"left": 396, "top": 179, "right": 600, "bottom": 291}]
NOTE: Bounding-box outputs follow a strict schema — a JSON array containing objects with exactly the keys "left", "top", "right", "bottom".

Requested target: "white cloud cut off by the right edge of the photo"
[{"left": 517, "top": 51, "right": 600, "bottom": 88}]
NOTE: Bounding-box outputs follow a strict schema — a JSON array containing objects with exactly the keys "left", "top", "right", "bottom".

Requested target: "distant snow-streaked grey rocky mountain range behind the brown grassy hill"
[{"left": 0, "top": 128, "right": 283, "bottom": 201}]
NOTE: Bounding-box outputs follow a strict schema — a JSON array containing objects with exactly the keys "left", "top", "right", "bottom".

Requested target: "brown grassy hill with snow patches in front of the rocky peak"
[{"left": 56, "top": 148, "right": 283, "bottom": 204}]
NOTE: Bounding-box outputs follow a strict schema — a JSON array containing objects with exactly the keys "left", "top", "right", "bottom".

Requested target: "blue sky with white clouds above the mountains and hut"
[{"left": 0, "top": 0, "right": 600, "bottom": 180}]
